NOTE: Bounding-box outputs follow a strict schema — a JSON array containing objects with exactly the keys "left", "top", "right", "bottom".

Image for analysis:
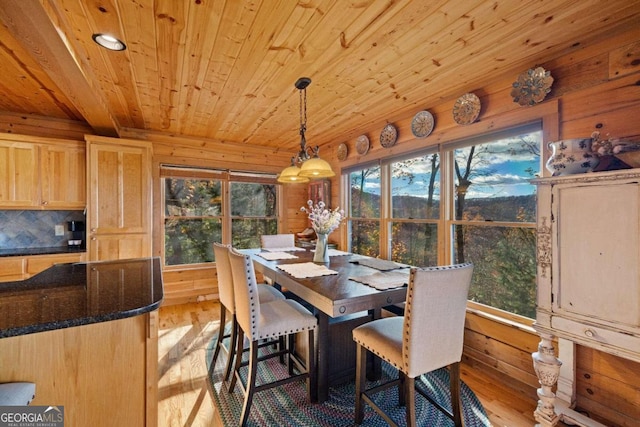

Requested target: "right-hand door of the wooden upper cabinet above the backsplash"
[{"left": 40, "top": 145, "right": 87, "bottom": 209}]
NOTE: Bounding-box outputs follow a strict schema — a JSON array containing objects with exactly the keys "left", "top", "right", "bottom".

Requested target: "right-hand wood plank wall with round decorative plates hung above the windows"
[{"left": 322, "top": 27, "right": 640, "bottom": 427}]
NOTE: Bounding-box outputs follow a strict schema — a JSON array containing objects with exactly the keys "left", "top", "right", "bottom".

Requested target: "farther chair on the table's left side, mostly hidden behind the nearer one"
[{"left": 209, "top": 243, "right": 285, "bottom": 381}]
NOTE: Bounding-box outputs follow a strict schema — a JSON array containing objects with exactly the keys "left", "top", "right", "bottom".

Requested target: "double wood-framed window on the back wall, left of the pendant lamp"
[{"left": 161, "top": 166, "right": 278, "bottom": 266}]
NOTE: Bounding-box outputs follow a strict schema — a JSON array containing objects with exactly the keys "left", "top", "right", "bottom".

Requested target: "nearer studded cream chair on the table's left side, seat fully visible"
[{"left": 229, "top": 250, "right": 318, "bottom": 426}]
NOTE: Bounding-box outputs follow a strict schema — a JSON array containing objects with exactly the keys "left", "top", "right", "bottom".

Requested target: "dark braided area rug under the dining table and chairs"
[{"left": 206, "top": 337, "right": 491, "bottom": 427}]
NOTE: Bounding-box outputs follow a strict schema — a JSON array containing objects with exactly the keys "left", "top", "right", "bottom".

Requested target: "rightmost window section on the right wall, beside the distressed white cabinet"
[{"left": 449, "top": 129, "right": 542, "bottom": 318}]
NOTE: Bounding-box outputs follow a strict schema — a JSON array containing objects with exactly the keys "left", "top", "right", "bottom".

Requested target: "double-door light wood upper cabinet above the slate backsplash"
[{"left": 0, "top": 134, "right": 86, "bottom": 210}]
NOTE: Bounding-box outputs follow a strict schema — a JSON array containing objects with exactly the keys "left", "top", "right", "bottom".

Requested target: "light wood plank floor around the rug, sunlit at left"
[{"left": 158, "top": 301, "right": 537, "bottom": 427}]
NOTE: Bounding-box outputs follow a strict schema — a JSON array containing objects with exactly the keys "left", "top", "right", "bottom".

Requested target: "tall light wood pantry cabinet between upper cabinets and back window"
[{"left": 86, "top": 135, "right": 152, "bottom": 261}]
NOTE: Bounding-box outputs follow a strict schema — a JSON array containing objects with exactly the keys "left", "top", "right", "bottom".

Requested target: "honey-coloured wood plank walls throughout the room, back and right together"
[{"left": 0, "top": 27, "right": 640, "bottom": 426}]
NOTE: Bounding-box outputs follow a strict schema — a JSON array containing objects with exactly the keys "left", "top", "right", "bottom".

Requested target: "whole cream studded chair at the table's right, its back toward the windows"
[{"left": 353, "top": 263, "right": 473, "bottom": 427}]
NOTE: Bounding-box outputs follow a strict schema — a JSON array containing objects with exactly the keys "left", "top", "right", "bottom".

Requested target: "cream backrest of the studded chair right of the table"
[{"left": 402, "top": 263, "right": 473, "bottom": 378}]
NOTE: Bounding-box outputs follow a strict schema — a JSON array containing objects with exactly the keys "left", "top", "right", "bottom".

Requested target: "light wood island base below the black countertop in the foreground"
[{"left": 0, "top": 310, "right": 158, "bottom": 427}]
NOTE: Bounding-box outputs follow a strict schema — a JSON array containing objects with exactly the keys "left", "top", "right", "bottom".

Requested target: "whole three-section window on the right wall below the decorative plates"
[{"left": 345, "top": 124, "right": 542, "bottom": 318}]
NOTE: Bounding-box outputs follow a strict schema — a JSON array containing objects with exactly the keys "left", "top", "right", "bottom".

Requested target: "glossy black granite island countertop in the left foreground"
[{"left": 0, "top": 257, "right": 164, "bottom": 338}]
